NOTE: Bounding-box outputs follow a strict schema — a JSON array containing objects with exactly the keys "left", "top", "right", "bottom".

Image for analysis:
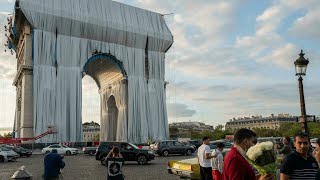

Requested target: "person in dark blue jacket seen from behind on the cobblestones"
[{"left": 43, "top": 149, "right": 65, "bottom": 180}]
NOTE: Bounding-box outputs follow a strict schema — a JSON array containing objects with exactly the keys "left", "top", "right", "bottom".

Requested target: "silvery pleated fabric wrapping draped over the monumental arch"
[{"left": 19, "top": 0, "right": 173, "bottom": 142}]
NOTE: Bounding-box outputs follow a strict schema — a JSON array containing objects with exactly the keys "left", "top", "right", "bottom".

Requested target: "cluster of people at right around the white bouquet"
[{"left": 197, "top": 129, "right": 320, "bottom": 180}]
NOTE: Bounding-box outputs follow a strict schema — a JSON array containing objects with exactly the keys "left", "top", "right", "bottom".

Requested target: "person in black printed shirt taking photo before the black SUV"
[{"left": 105, "top": 146, "right": 124, "bottom": 180}]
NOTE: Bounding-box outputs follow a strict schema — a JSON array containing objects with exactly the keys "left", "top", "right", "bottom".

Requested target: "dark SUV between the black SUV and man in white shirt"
[{"left": 150, "top": 140, "right": 195, "bottom": 156}]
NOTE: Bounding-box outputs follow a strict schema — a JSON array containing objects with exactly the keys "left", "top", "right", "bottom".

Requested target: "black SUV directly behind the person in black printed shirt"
[{"left": 96, "top": 142, "right": 155, "bottom": 165}]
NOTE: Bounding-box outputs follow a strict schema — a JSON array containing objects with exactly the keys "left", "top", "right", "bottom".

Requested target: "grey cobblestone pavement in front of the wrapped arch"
[{"left": 0, "top": 154, "right": 193, "bottom": 180}]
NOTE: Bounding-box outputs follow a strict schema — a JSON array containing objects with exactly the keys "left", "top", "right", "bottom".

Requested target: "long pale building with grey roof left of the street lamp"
[{"left": 225, "top": 114, "right": 298, "bottom": 130}]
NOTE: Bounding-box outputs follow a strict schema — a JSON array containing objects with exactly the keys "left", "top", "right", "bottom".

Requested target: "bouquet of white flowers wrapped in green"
[{"left": 247, "top": 141, "right": 278, "bottom": 175}]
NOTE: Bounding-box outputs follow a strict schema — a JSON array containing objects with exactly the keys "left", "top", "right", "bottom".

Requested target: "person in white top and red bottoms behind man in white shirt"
[{"left": 211, "top": 143, "right": 224, "bottom": 180}]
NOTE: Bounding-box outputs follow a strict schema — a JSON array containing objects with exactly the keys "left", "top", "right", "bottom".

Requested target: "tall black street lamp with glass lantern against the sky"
[{"left": 294, "top": 50, "right": 309, "bottom": 133}]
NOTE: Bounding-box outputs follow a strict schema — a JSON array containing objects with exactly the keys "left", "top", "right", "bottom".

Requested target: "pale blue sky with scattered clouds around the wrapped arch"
[{"left": 0, "top": 0, "right": 320, "bottom": 128}]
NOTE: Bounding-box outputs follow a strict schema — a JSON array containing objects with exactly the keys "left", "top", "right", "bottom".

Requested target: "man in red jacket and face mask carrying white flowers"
[{"left": 223, "top": 128, "right": 275, "bottom": 180}]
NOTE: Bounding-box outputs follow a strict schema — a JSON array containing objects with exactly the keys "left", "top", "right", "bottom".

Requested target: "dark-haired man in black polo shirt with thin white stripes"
[{"left": 280, "top": 132, "right": 319, "bottom": 180}]
